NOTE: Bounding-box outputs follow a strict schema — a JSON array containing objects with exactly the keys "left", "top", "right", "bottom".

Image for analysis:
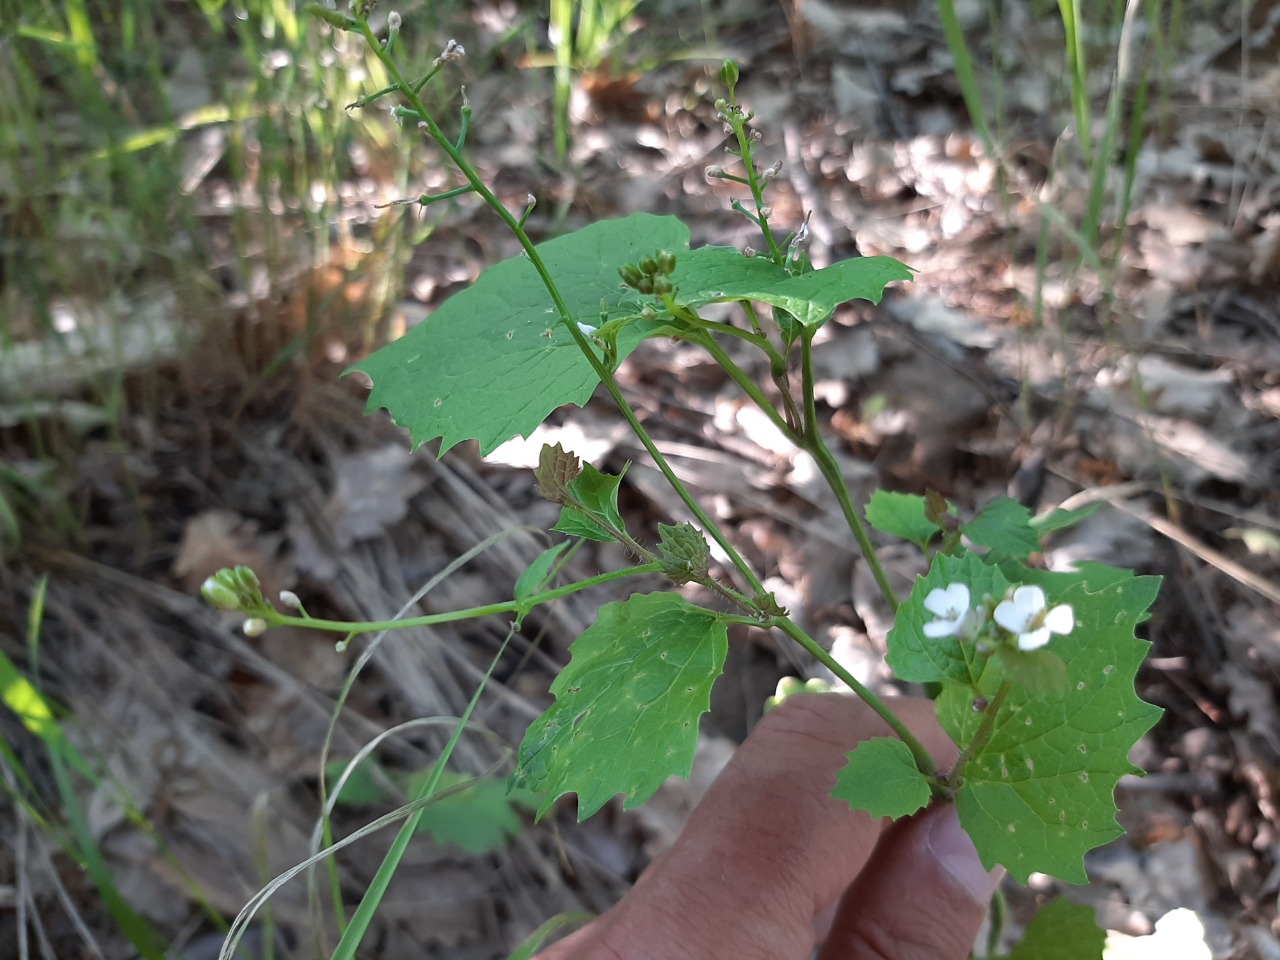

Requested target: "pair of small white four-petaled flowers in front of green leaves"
[{"left": 924, "top": 584, "right": 1075, "bottom": 650}]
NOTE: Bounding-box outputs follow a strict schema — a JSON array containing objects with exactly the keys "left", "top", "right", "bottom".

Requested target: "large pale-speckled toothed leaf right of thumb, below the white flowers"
[{"left": 937, "top": 564, "right": 1161, "bottom": 883}]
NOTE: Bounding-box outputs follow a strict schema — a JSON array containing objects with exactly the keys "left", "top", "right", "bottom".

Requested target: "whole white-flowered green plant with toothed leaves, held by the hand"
[{"left": 202, "top": 9, "right": 1160, "bottom": 960}]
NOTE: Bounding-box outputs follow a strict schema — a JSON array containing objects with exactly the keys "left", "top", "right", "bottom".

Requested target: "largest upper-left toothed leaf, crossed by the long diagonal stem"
[{"left": 351, "top": 214, "right": 689, "bottom": 456}]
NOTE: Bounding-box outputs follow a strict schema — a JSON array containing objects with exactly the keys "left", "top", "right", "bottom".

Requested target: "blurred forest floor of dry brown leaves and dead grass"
[{"left": 0, "top": 0, "right": 1280, "bottom": 960}]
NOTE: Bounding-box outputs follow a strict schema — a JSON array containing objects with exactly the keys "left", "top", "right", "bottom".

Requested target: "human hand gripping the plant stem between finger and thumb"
[{"left": 536, "top": 694, "right": 1004, "bottom": 960}]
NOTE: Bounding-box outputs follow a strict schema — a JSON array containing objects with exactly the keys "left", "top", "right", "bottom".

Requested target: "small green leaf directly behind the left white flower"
[{"left": 884, "top": 553, "right": 1009, "bottom": 684}]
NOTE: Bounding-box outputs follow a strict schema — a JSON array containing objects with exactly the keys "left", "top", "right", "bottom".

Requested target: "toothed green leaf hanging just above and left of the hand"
[{"left": 512, "top": 593, "right": 728, "bottom": 819}]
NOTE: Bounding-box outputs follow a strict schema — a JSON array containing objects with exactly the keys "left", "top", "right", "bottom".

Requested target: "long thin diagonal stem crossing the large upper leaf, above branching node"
[{"left": 360, "top": 22, "right": 765, "bottom": 594}]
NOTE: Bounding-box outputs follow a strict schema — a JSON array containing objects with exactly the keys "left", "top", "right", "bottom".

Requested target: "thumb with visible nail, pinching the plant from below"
[{"left": 819, "top": 804, "right": 1005, "bottom": 960}]
